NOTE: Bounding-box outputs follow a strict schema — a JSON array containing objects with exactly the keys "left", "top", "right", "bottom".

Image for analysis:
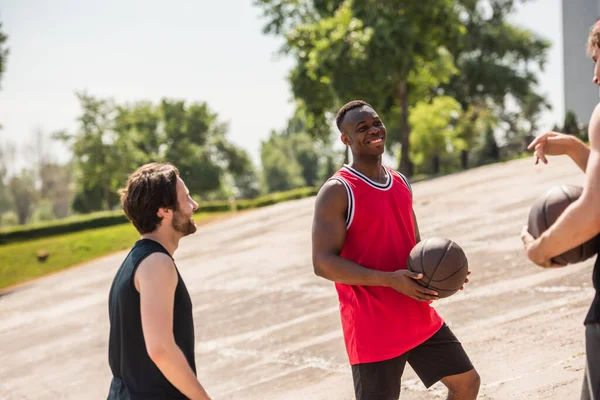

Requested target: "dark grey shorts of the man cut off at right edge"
[{"left": 581, "top": 324, "right": 600, "bottom": 400}]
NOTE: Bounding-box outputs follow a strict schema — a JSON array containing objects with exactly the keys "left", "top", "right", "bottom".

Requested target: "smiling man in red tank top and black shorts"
[{"left": 312, "top": 100, "right": 480, "bottom": 400}]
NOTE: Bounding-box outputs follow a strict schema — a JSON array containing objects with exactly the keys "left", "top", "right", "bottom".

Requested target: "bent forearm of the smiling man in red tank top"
[{"left": 313, "top": 254, "right": 389, "bottom": 286}]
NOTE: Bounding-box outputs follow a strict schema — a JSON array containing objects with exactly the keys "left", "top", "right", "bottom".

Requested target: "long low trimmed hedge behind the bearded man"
[{"left": 0, "top": 187, "right": 319, "bottom": 244}]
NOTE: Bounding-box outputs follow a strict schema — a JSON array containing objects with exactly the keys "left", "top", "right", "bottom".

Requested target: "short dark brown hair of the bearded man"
[{"left": 119, "top": 163, "right": 179, "bottom": 234}]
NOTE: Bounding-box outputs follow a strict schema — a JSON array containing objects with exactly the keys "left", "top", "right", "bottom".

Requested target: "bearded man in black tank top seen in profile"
[{"left": 108, "top": 163, "right": 210, "bottom": 400}]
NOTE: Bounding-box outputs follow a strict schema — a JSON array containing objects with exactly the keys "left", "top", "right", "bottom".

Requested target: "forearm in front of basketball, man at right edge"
[{"left": 539, "top": 199, "right": 598, "bottom": 259}]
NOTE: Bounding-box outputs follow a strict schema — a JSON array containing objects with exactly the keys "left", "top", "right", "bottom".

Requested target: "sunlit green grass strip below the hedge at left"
[{"left": 0, "top": 213, "right": 227, "bottom": 289}]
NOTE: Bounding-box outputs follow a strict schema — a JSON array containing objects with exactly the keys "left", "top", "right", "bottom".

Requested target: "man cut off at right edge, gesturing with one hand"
[{"left": 521, "top": 22, "right": 600, "bottom": 400}]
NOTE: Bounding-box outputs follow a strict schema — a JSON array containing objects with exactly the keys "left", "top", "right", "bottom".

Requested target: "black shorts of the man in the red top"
[{"left": 352, "top": 324, "right": 473, "bottom": 400}]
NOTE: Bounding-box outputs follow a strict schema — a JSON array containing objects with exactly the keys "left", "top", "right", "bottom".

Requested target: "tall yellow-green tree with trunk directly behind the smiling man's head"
[{"left": 256, "top": 0, "right": 461, "bottom": 175}]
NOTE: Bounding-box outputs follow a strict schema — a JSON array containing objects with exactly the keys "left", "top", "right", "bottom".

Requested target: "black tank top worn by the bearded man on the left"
[{"left": 108, "top": 239, "right": 196, "bottom": 400}]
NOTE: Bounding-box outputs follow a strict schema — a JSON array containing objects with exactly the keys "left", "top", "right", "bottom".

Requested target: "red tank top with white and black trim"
[{"left": 331, "top": 166, "right": 443, "bottom": 365}]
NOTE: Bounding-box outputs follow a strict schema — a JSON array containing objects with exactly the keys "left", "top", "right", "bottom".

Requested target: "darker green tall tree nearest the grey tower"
[{"left": 442, "top": 0, "right": 550, "bottom": 161}]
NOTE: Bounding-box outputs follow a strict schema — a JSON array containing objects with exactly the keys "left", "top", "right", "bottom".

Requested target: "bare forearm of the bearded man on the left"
[{"left": 152, "top": 343, "right": 210, "bottom": 400}]
